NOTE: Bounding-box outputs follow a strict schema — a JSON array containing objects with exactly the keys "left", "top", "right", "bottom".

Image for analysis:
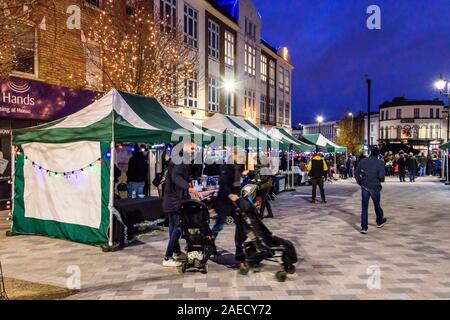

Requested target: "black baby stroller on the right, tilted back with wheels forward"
[{"left": 236, "top": 184, "right": 298, "bottom": 282}]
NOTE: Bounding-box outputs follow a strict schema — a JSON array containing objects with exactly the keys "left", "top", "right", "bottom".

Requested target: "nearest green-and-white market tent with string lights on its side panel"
[{"left": 12, "top": 90, "right": 205, "bottom": 245}]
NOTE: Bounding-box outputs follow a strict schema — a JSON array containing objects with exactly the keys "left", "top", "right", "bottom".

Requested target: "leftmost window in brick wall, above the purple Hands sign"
[{"left": 12, "top": 26, "right": 37, "bottom": 75}]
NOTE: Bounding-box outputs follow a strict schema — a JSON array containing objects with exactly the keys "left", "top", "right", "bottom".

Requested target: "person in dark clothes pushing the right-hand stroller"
[{"left": 212, "top": 153, "right": 245, "bottom": 266}]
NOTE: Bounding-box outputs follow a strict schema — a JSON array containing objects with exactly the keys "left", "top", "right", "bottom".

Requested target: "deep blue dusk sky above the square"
[{"left": 253, "top": 0, "right": 450, "bottom": 125}]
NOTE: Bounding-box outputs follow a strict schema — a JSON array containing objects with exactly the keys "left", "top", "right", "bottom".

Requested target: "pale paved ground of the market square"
[{"left": 0, "top": 178, "right": 450, "bottom": 299}]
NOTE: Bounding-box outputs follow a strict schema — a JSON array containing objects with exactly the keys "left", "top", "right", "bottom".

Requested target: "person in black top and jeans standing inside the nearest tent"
[{"left": 127, "top": 144, "right": 148, "bottom": 198}]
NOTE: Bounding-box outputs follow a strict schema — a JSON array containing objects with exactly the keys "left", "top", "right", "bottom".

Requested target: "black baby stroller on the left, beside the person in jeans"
[{"left": 180, "top": 200, "right": 216, "bottom": 273}]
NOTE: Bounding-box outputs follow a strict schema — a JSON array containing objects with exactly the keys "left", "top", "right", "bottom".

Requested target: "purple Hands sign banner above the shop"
[{"left": 0, "top": 77, "right": 98, "bottom": 121}]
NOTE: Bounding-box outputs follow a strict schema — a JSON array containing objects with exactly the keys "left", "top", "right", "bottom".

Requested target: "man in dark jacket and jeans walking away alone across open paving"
[{"left": 355, "top": 147, "right": 387, "bottom": 234}]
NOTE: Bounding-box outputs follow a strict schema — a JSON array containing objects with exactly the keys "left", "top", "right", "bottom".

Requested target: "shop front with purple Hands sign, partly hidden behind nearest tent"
[{"left": 0, "top": 77, "right": 97, "bottom": 210}]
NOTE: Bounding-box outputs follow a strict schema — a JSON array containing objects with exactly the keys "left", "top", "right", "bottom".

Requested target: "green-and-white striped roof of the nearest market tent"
[{"left": 13, "top": 89, "right": 204, "bottom": 144}]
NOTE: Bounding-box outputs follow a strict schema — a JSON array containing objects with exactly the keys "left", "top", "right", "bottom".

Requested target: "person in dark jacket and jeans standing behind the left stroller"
[{"left": 163, "top": 161, "right": 199, "bottom": 267}]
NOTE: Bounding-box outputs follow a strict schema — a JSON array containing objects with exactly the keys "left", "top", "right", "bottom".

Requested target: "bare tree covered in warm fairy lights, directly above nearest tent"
[{"left": 85, "top": 0, "right": 198, "bottom": 105}]
